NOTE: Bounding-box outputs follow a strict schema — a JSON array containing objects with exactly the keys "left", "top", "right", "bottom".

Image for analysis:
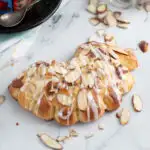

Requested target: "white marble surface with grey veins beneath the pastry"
[{"left": 0, "top": 0, "right": 150, "bottom": 150}]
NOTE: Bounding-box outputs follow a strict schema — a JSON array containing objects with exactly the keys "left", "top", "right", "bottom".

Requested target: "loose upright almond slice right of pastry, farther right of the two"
[{"left": 132, "top": 94, "right": 143, "bottom": 112}]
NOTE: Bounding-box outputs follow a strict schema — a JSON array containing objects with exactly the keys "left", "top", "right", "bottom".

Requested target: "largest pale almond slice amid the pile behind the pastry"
[{"left": 106, "top": 13, "right": 117, "bottom": 27}]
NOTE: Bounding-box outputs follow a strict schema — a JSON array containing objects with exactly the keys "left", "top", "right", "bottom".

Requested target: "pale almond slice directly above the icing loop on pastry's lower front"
[{"left": 57, "top": 94, "right": 72, "bottom": 106}]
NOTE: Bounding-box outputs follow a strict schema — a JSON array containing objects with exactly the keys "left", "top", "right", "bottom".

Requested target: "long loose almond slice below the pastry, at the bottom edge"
[{"left": 37, "top": 133, "right": 63, "bottom": 150}]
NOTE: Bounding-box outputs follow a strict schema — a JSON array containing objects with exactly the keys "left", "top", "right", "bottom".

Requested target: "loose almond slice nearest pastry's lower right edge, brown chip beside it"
[{"left": 120, "top": 108, "right": 130, "bottom": 125}]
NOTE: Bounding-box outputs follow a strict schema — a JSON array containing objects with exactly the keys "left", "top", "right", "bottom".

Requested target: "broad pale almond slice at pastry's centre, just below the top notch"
[{"left": 65, "top": 69, "right": 81, "bottom": 83}]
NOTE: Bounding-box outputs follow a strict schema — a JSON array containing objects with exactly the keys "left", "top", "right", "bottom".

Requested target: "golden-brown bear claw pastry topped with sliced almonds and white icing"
[{"left": 8, "top": 42, "right": 138, "bottom": 125}]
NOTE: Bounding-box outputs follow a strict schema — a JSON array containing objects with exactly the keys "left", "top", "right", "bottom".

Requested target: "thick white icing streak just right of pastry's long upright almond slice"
[{"left": 87, "top": 92, "right": 98, "bottom": 120}]
